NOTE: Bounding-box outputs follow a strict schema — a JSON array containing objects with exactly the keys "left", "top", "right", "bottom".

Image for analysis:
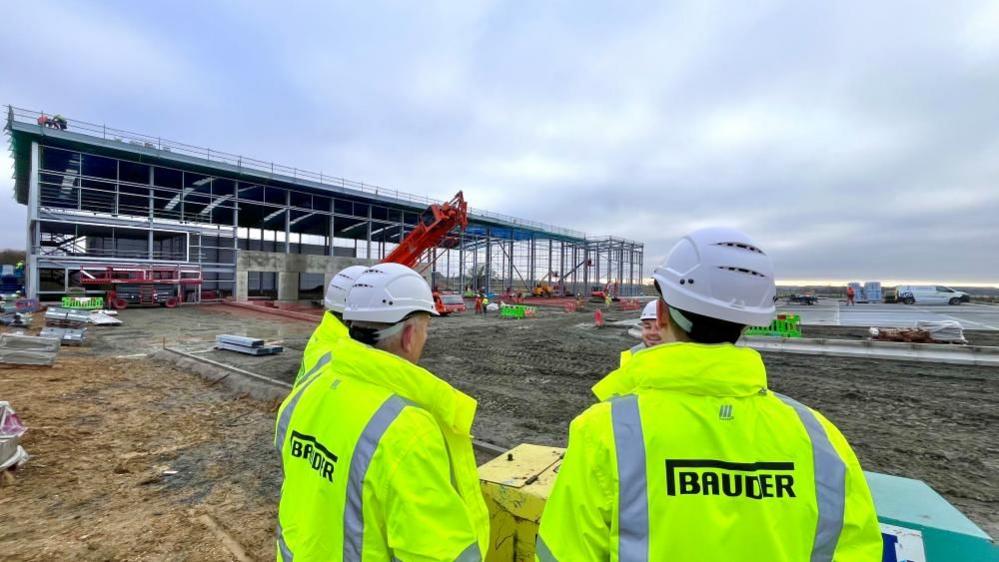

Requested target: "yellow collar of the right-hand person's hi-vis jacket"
[{"left": 593, "top": 342, "right": 767, "bottom": 400}]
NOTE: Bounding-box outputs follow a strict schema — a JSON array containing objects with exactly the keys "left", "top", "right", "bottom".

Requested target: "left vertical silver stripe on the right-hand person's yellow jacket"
[{"left": 611, "top": 394, "right": 649, "bottom": 560}]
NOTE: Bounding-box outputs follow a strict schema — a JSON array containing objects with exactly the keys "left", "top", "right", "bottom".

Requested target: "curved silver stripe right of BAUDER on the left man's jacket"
[{"left": 343, "top": 396, "right": 406, "bottom": 562}]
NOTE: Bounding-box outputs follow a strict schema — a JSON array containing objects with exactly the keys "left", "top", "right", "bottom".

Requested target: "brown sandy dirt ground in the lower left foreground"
[{"left": 0, "top": 349, "right": 280, "bottom": 561}]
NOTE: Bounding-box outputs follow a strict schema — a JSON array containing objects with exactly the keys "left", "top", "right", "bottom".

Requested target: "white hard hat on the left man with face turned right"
[{"left": 343, "top": 263, "right": 438, "bottom": 324}]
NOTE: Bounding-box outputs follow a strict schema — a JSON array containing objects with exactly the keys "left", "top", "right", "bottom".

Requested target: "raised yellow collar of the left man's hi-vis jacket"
[{"left": 332, "top": 338, "right": 477, "bottom": 437}]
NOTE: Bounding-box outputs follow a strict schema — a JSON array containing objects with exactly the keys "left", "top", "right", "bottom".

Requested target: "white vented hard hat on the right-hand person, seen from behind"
[{"left": 652, "top": 227, "right": 776, "bottom": 326}]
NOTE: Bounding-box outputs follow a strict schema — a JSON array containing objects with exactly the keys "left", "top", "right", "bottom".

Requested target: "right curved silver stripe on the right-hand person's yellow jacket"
[{"left": 774, "top": 392, "right": 846, "bottom": 562}]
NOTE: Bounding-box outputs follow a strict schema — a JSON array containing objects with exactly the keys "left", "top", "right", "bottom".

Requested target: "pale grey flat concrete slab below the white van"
[{"left": 778, "top": 302, "right": 999, "bottom": 330}]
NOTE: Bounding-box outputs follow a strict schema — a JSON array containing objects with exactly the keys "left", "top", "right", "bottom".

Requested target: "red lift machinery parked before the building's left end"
[{"left": 80, "top": 264, "right": 202, "bottom": 310}]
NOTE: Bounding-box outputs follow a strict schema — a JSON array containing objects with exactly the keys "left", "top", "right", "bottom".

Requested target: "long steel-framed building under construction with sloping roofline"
[{"left": 5, "top": 106, "right": 644, "bottom": 304}]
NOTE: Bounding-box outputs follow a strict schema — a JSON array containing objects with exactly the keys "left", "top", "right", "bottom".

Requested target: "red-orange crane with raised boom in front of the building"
[{"left": 382, "top": 191, "right": 468, "bottom": 315}]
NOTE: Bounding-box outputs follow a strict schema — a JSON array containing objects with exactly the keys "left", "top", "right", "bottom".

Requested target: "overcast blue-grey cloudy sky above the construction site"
[{"left": 0, "top": 0, "right": 999, "bottom": 284}]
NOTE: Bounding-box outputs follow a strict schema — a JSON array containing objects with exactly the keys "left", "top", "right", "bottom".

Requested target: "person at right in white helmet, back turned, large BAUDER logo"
[{"left": 536, "top": 228, "right": 882, "bottom": 562}]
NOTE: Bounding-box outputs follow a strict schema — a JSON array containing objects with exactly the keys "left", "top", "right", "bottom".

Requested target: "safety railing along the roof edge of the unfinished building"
[{"left": 7, "top": 105, "right": 639, "bottom": 244}]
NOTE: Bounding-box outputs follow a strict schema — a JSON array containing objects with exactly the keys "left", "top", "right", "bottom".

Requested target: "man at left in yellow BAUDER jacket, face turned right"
[{"left": 274, "top": 263, "right": 489, "bottom": 562}]
